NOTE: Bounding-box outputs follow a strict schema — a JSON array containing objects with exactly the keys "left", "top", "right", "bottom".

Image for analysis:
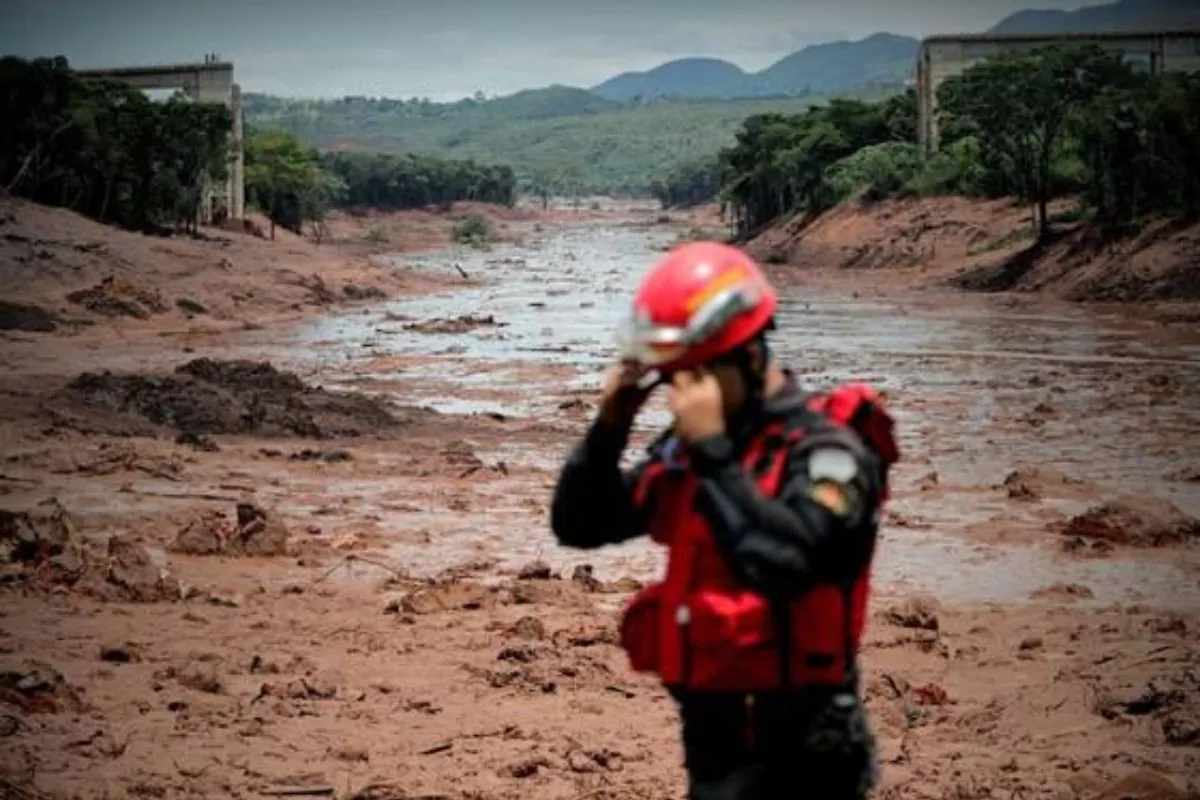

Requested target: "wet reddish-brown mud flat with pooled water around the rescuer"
[{"left": 0, "top": 203, "right": 1200, "bottom": 800}]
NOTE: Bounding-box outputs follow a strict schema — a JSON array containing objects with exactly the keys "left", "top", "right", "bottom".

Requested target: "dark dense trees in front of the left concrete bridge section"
[{"left": 0, "top": 58, "right": 232, "bottom": 230}]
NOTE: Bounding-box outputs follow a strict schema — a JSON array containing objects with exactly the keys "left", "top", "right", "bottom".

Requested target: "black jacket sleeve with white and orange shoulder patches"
[{"left": 689, "top": 431, "right": 881, "bottom": 597}]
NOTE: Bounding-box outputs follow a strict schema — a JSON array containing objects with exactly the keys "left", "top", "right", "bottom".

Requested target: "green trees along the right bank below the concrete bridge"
[{"left": 700, "top": 46, "right": 1200, "bottom": 236}]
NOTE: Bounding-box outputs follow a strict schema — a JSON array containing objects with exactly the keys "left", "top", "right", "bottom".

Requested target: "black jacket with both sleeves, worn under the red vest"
[{"left": 551, "top": 374, "right": 882, "bottom": 597}]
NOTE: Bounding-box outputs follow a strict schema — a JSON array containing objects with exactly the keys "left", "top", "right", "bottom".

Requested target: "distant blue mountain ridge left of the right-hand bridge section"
[{"left": 592, "top": 34, "right": 919, "bottom": 101}]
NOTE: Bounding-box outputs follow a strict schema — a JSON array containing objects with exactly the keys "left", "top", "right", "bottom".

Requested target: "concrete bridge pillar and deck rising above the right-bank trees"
[{"left": 917, "top": 30, "right": 1200, "bottom": 158}]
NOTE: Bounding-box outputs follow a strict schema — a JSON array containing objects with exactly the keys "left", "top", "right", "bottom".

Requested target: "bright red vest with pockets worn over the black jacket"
[{"left": 620, "top": 385, "right": 898, "bottom": 692}]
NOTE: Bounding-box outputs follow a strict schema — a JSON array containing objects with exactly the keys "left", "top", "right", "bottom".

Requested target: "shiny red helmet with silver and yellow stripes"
[{"left": 620, "top": 241, "right": 779, "bottom": 371}]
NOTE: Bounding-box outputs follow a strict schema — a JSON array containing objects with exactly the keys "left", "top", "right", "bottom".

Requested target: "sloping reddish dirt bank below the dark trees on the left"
[{"left": 0, "top": 199, "right": 458, "bottom": 332}]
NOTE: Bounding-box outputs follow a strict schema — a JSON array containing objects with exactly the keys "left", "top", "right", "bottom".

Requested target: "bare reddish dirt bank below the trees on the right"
[{"left": 748, "top": 197, "right": 1200, "bottom": 302}]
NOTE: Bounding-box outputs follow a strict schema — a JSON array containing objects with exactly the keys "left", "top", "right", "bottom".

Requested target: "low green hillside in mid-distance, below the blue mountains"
[{"left": 242, "top": 86, "right": 902, "bottom": 193}]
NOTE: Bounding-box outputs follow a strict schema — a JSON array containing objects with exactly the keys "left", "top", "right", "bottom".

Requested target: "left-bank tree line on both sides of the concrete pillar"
[{"left": 0, "top": 58, "right": 517, "bottom": 239}]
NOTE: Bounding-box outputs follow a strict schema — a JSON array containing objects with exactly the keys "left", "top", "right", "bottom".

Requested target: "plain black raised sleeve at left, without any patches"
[{"left": 550, "top": 420, "right": 649, "bottom": 549}]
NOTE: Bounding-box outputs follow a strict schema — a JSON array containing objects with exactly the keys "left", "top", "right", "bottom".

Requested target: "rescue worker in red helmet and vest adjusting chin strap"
[{"left": 551, "top": 242, "right": 899, "bottom": 800}]
